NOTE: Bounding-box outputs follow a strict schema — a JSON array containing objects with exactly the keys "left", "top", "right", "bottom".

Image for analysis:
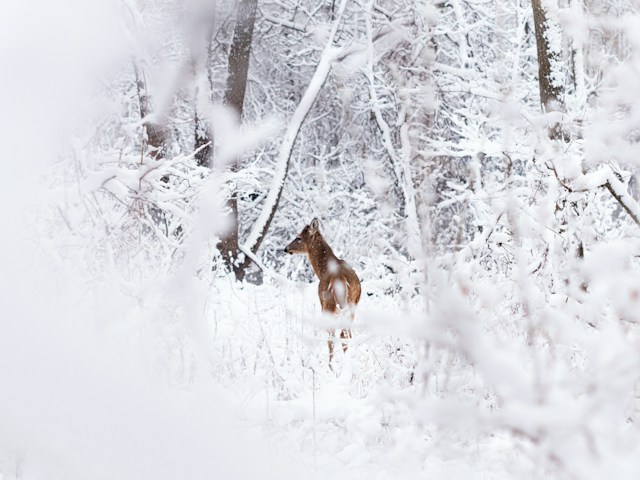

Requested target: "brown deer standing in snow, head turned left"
[{"left": 284, "top": 218, "right": 360, "bottom": 369}]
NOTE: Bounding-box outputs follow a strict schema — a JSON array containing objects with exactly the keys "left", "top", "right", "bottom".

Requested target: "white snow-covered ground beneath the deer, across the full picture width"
[{"left": 0, "top": 213, "right": 640, "bottom": 480}]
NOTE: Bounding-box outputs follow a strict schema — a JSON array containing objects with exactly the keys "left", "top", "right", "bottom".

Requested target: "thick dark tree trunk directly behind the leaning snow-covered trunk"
[{"left": 218, "top": 0, "right": 258, "bottom": 280}]
